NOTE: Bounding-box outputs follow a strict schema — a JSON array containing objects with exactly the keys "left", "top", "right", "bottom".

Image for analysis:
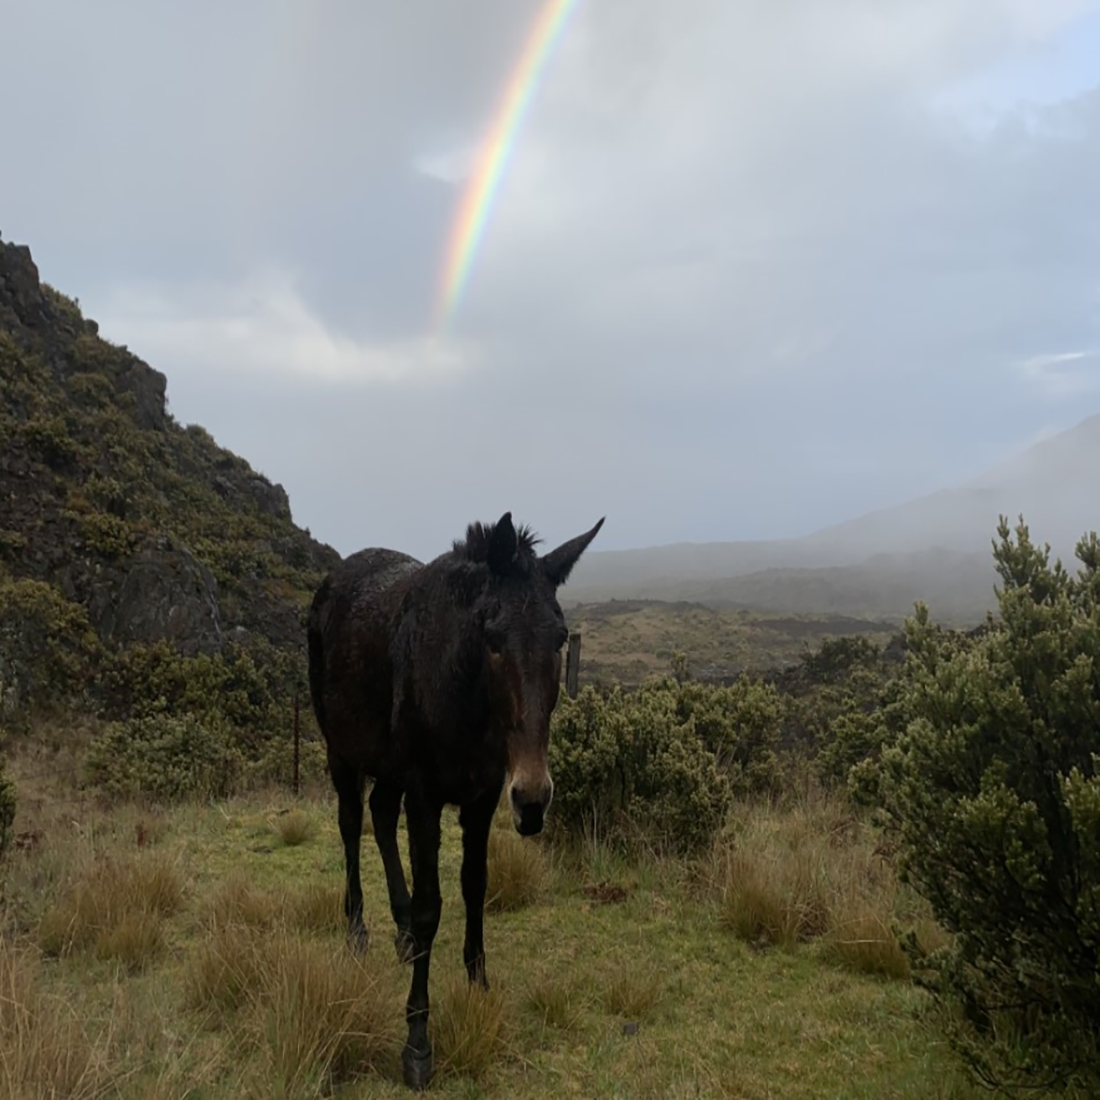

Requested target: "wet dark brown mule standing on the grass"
[{"left": 308, "top": 513, "right": 604, "bottom": 1088}]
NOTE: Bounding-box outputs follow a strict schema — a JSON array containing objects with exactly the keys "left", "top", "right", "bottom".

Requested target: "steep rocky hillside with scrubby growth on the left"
[{"left": 0, "top": 241, "right": 339, "bottom": 655}]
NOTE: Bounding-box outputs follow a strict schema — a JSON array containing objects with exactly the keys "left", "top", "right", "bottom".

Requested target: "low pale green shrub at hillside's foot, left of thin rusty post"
[{"left": 85, "top": 714, "right": 242, "bottom": 802}]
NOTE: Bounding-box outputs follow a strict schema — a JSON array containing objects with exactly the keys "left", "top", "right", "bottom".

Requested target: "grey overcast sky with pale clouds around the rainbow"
[{"left": 0, "top": 0, "right": 1100, "bottom": 557}]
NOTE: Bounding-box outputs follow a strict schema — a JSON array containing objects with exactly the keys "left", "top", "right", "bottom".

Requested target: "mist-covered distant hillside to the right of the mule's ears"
[{"left": 563, "top": 415, "right": 1100, "bottom": 624}]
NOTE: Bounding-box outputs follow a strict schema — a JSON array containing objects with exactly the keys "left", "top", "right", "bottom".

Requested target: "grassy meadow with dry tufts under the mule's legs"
[{"left": 0, "top": 736, "right": 976, "bottom": 1100}]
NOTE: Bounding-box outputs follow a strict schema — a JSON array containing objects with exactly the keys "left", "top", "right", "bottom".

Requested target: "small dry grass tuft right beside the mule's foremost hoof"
[{"left": 429, "top": 975, "right": 505, "bottom": 1079}]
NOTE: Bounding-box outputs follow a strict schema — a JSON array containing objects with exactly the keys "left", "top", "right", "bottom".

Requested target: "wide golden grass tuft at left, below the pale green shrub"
[{"left": 39, "top": 855, "right": 184, "bottom": 966}]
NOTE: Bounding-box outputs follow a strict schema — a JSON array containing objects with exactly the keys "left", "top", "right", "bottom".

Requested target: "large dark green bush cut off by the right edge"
[{"left": 882, "top": 518, "right": 1100, "bottom": 1095}]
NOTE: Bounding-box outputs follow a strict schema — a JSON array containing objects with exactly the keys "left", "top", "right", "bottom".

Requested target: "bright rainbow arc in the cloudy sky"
[{"left": 435, "top": 0, "right": 579, "bottom": 331}]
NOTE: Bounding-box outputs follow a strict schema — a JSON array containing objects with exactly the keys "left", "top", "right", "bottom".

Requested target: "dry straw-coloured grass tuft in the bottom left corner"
[{"left": 0, "top": 942, "right": 112, "bottom": 1100}]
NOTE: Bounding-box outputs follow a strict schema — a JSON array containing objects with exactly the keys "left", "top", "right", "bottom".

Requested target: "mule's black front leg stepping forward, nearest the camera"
[{"left": 402, "top": 787, "right": 443, "bottom": 1089}]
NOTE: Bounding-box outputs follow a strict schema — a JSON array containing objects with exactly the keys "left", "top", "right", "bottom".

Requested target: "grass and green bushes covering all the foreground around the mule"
[{"left": 0, "top": 524, "right": 1100, "bottom": 1100}]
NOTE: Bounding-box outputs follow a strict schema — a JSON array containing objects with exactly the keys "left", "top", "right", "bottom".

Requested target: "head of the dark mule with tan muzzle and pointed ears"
[{"left": 464, "top": 513, "right": 604, "bottom": 836}]
